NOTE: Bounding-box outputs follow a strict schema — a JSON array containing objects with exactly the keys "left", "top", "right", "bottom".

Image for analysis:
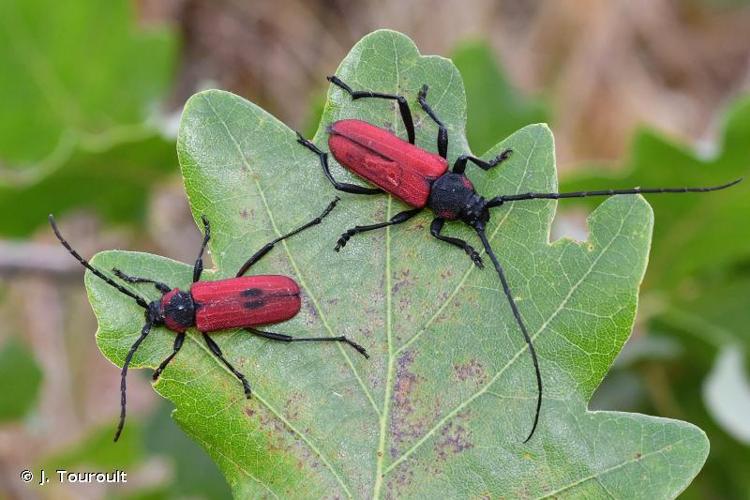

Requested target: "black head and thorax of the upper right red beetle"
[{"left": 427, "top": 172, "right": 490, "bottom": 227}]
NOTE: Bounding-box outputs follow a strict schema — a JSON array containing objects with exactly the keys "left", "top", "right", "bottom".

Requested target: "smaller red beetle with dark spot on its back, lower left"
[{"left": 49, "top": 198, "right": 369, "bottom": 441}]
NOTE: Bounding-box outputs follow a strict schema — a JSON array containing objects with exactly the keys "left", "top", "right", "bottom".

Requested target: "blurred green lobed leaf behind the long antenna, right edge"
[{"left": 561, "top": 98, "right": 750, "bottom": 292}]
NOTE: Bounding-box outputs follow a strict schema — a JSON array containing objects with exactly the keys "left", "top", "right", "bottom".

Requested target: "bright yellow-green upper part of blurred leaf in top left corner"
[{"left": 0, "top": 0, "right": 175, "bottom": 168}]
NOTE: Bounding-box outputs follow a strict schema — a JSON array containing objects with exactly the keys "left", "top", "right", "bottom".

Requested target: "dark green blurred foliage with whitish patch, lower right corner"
[{"left": 656, "top": 274, "right": 750, "bottom": 498}]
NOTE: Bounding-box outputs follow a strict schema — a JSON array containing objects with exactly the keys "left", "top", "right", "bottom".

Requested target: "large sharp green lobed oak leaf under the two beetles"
[{"left": 86, "top": 31, "right": 708, "bottom": 498}]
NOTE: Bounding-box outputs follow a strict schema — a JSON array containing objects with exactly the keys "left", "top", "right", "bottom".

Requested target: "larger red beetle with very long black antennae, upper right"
[{"left": 297, "top": 76, "right": 742, "bottom": 442}]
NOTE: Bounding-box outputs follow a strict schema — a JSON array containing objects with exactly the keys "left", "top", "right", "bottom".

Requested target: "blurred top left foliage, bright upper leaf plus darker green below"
[{"left": 0, "top": 0, "right": 177, "bottom": 236}]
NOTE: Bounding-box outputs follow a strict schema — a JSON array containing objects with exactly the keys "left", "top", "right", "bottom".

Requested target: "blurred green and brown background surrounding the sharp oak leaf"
[{"left": 0, "top": 0, "right": 750, "bottom": 499}]
